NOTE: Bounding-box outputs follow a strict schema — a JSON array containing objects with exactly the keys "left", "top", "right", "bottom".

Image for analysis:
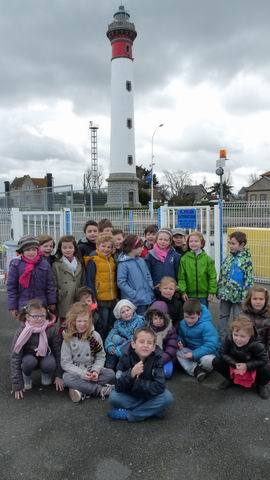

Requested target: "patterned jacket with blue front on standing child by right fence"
[{"left": 218, "top": 249, "right": 254, "bottom": 303}]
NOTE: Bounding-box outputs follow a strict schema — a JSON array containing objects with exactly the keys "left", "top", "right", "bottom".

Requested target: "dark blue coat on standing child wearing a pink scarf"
[{"left": 145, "top": 247, "right": 180, "bottom": 287}]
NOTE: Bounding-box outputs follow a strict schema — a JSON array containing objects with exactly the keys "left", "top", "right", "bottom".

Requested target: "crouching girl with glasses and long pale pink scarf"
[{"left": 11, "top": 299, "right": 64, "bottom": 400}]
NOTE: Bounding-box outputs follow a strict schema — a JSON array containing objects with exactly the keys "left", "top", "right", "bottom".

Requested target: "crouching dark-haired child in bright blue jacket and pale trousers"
[{"left": 177, "top": 299, "right": 219, "bottom": 382}]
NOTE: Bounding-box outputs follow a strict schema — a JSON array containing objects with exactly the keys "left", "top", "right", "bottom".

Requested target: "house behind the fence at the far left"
[{"left": 5, "top": 173, "right": 53, "bottom": 210}]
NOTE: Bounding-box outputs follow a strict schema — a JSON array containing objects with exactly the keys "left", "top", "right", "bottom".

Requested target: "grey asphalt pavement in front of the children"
[{"left": 0, "top": 289, "right": 270, "bottom": 480}]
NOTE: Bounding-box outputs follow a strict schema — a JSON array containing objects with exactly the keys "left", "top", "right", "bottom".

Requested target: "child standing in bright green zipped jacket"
[{"left": 178, "top": 231, "right": 217, "bottom": 306}]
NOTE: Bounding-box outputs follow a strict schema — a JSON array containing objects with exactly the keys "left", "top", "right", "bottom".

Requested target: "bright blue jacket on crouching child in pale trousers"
[{"left": 178, "top": 305, "right": 220, "bottom": 361}]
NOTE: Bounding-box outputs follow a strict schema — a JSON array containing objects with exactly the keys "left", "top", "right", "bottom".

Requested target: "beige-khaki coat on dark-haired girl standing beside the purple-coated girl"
[{"left": 52, "top": 258, "right": 84, "bottom": 318}]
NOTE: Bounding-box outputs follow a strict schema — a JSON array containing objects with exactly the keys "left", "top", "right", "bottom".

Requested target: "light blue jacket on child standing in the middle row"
[{"left": 117, "top": 254, "right": 155, "bottom": 306}]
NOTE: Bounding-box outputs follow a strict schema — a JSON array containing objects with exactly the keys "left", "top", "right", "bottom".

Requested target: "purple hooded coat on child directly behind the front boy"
[{"left": 145, "top": 309, "right": 178, "bottom": 363}]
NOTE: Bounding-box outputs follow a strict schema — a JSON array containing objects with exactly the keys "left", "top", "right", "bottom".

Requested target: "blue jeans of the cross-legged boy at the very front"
[{"left": 109, "top": 389, "right": 173, "bottom": 422}]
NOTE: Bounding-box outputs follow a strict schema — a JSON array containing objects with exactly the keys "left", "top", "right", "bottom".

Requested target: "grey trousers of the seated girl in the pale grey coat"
[{"left": 63, "top": 368, "right": 115, "bottom": 397}]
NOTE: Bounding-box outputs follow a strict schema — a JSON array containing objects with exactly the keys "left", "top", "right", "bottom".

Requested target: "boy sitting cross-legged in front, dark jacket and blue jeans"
[{"left": 108, "top": 327, "right": 173, "bottom": 422}]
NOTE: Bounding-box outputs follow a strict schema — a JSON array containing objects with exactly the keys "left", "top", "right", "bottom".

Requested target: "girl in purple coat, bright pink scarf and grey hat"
[{"left": 7, "top": 235, "right": 56, "bottom": 317}]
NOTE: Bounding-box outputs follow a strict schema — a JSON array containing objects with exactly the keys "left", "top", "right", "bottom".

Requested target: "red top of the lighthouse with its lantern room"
[{"left": 107, "top": 5, "right": 137, "bottom": 60}]
